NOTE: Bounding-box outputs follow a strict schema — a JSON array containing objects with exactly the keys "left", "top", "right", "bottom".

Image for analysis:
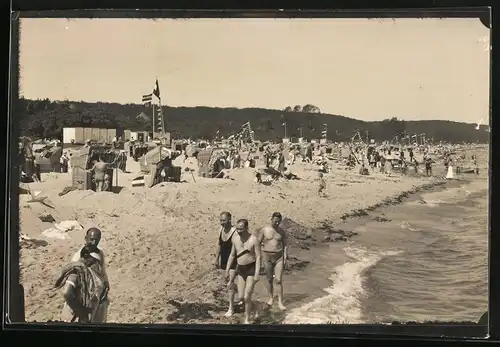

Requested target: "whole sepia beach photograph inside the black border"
[{"left": 11, "top": 18, "right": 491, "bottom": 324}]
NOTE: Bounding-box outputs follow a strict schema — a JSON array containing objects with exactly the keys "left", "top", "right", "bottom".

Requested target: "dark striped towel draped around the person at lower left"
[{"left": 54, "top": 262, "right": 105, "bottom": 318}]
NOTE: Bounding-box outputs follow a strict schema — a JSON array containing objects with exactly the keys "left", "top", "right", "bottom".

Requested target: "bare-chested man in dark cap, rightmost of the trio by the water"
[{"left": 259, "top": 212, "right": 288, "bottom": 311}]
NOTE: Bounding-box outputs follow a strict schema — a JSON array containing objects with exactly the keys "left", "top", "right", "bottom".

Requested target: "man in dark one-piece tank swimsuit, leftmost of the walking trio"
[{"left": 215, "top": 212, "right": 236, "bottom": 317}]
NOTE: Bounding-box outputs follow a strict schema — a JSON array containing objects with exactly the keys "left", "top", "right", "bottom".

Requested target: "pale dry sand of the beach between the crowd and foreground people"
[{"left": 20, "top": 158, "right": 450, "bottom": 323}]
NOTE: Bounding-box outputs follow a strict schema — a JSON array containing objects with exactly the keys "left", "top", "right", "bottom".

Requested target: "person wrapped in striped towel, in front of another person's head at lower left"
[{"left": 54, "top": 246, "right": 108, "bottom": 323}]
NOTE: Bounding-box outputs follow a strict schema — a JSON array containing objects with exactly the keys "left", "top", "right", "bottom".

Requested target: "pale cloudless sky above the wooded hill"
[{"left": 20, "top": 19, "right": 490, "bottom": 124}]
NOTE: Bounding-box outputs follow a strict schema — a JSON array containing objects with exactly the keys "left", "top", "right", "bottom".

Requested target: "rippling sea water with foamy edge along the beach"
[{"left": 284, "top": 176, "right": 488, "bottom": 324}]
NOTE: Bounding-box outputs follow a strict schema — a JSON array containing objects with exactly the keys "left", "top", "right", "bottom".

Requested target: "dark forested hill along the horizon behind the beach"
[{"left": 13, "top": 99, "right": 490, "bottom": 143}]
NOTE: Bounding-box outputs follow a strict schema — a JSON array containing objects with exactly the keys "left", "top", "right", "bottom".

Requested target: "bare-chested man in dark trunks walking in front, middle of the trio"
[{"left": 226, "top": 219, "right": 261, "bottom": 324}]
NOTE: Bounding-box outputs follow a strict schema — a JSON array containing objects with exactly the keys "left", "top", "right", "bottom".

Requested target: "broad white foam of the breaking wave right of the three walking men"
[{"left": 284, "top": 246, "right": 401, "bottom": 324}]
